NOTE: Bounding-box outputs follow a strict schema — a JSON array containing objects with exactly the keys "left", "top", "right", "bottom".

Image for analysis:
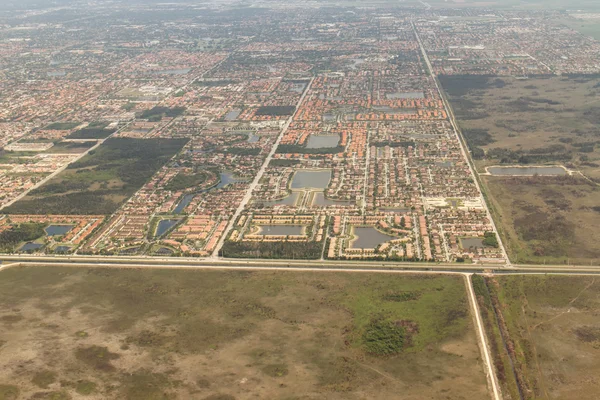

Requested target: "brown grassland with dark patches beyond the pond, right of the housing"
[{"left": 440, "top": 76, "right": 600, "bottom": 182}]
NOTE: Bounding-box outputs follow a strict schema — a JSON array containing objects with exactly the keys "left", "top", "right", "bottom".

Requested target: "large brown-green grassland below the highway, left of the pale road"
[{"left": 0, "top": 267, "right": 489, "bottom": 400}]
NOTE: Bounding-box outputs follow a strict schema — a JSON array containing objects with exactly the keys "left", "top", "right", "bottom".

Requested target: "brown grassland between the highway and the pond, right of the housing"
[{"left": 482, "top": 176, "right": 600, "bottom": 265}]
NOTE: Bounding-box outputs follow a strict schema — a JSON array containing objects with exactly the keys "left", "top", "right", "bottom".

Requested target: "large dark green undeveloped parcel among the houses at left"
[{"left": 4, "top": 138, "right": 187, "bottom": 215}]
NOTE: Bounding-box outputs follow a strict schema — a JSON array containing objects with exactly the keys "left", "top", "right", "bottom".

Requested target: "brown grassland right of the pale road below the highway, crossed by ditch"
[{"left": 473, "top": 276, "right": 600, "bottom": 400}]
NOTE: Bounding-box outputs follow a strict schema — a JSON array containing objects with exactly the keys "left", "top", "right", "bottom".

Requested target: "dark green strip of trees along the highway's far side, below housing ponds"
[{"left": 219, "top": 241, "right": 323, "bottom": 260}]
